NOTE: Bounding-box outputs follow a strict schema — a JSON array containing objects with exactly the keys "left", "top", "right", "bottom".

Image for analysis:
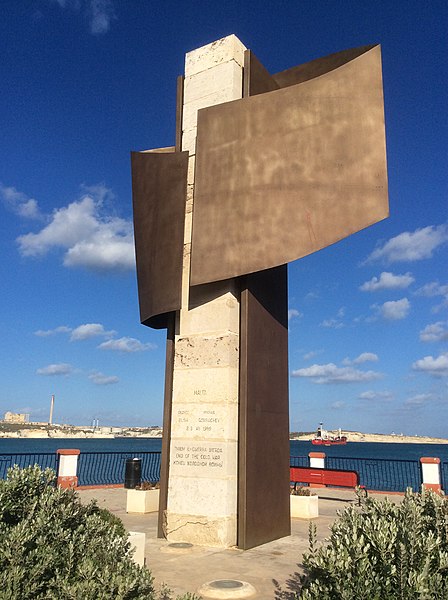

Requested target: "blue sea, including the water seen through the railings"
[{"left": 0, "top": 437, "right": 448, "bottom": 491}]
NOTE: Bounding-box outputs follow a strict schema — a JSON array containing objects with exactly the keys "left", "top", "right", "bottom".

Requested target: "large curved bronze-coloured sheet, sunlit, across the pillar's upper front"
[{"left": 191, "top": 46, "right": 388, "bottom": 285}]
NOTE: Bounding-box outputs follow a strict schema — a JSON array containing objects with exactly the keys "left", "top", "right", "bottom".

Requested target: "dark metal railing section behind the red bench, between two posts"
[{"left": 325, "top": 456, "right": 422, "bottom": 492}]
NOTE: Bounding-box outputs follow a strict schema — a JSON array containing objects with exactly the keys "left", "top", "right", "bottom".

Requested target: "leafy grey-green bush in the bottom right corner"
[{"left": 296, "top": 490, "right": 448, "bottom": 600}]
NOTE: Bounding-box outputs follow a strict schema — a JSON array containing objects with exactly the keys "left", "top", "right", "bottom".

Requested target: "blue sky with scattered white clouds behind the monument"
[{"left": 0, "top": 0, "right": 448, "bottom": 437}]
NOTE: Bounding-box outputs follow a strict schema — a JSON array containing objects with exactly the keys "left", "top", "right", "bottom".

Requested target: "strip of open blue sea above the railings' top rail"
[{"left": 0, "top": 437, "right": 448, "bottom": 462}]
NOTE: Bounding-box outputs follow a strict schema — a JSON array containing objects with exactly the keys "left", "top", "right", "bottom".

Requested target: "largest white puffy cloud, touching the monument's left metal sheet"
[{"left": 17, "top": 186, "right": 135, "bottom": 271}]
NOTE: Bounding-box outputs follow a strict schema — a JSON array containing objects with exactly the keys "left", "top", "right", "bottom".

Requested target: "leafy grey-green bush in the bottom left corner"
[{"left": 0, "top": 466, "right": 156, "bottom": 600}]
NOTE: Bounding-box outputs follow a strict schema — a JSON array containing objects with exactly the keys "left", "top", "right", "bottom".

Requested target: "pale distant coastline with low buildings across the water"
[{"left": 0, "top": 422, "right": 448, "bottom": 444}]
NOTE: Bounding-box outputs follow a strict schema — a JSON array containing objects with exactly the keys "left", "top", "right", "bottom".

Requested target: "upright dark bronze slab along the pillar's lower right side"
[{"left": 238, "top": 265, "right": 291, "bottom": 549}]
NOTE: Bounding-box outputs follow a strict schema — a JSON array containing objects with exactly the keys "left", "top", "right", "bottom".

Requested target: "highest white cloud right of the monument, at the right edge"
[{"left": 366, "top": 225, "right": 448, "bottom": 263}]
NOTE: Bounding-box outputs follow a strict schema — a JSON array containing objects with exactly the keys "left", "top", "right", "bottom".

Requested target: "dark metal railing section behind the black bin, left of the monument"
[{"left": 78, "top": 452, "right": 161, "bottom": 485}]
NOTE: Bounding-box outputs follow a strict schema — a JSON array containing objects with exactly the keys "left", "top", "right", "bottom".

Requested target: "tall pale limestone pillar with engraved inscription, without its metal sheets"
[{"left": 164, "top": 35, "right": 245, "bottom": 546}]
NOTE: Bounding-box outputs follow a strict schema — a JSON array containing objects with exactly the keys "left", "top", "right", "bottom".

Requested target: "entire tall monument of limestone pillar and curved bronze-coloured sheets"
[{"left": 131, "top": 35, "right": 388, "bottom": 548}]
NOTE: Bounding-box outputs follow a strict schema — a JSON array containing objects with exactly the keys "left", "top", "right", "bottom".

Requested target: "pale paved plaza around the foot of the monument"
[{"left": 79, "top": 488, "right": 401, "bottom": 600}]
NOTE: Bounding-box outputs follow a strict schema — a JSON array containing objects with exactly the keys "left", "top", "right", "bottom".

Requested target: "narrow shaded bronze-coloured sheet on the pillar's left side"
[{"left": 131, "top": 149, "right": 188, "bottom": 328}]
